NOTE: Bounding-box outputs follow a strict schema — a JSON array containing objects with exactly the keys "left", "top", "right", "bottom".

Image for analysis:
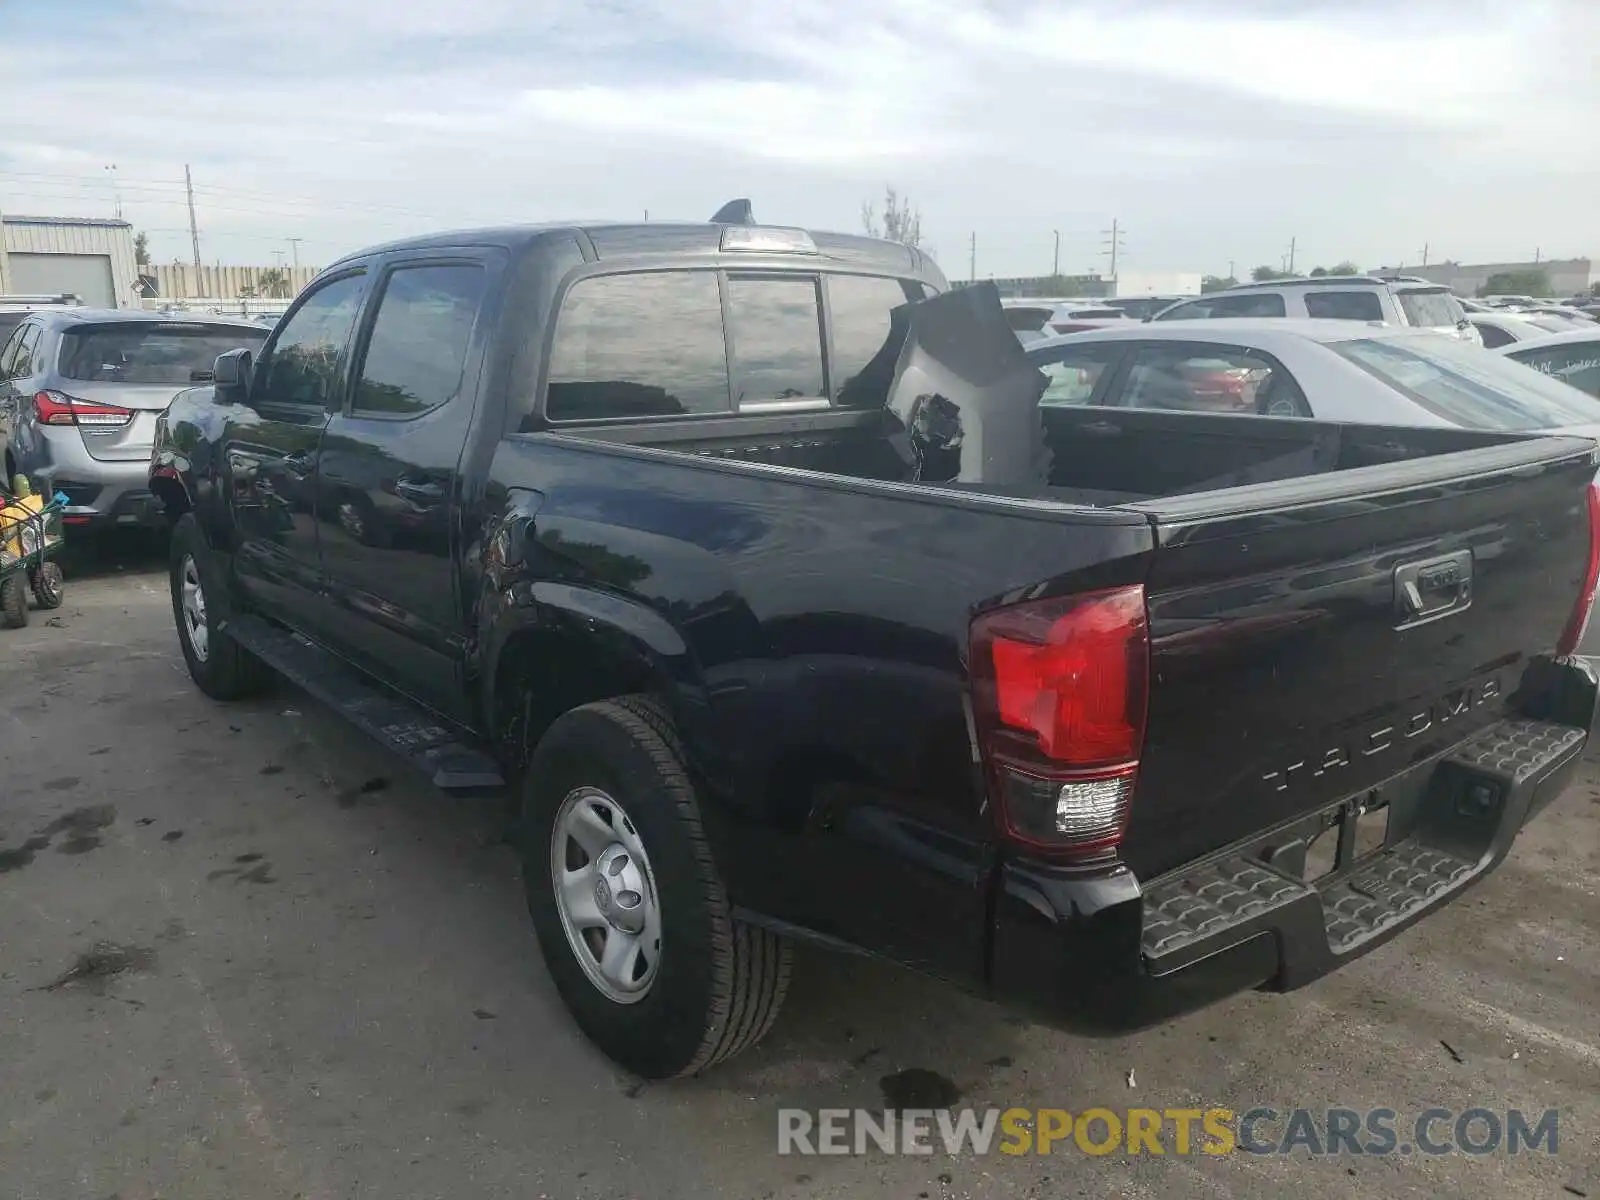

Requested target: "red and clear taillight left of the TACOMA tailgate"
[{"left": 971, "top": 586, "right": 1150, "bottom": 858}]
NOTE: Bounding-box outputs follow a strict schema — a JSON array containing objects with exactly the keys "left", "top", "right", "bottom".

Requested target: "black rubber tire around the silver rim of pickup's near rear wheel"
[{"left": 518, "top": 696, "right": 790, "bottom": 1078}]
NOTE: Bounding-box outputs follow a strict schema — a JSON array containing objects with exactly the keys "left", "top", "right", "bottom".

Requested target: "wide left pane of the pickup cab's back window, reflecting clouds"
[{"left": 546, "top": 270, "right": 729, "bottom": 421}]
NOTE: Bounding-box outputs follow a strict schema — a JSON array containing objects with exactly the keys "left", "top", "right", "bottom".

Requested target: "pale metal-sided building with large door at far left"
[{"left": 0, "top": 213, "right": 139, "bottom": 309}]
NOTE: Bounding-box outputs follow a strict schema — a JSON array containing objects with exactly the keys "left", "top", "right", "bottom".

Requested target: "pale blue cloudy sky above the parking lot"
[{"left": 0, "top": 0, "right": 1600, "bottom": 278}]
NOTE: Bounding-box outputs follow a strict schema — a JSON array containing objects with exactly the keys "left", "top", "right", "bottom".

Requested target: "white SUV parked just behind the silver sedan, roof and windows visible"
[{"left": 1150, "top": 283, "right": 1483, "bottom": 346}]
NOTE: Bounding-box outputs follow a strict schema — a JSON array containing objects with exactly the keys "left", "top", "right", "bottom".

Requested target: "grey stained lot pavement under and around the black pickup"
[{"left": 0, "top": 544, "right": 1600, "bottom": 1200}]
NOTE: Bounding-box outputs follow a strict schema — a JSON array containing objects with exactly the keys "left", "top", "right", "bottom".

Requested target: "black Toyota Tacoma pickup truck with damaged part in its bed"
[{"left": 150, "top": 214, "right": 1600, "bottom": 1077}]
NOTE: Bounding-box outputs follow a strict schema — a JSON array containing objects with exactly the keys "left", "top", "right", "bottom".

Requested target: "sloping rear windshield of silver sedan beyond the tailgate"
[{"left": 1328, "top": 338, "right": 1600, "bottom": 429}]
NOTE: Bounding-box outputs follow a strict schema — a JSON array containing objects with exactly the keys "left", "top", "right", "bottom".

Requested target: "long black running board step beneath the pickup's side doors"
[{"left": 226, "top": 614, "right": 506, "bottom": 794}]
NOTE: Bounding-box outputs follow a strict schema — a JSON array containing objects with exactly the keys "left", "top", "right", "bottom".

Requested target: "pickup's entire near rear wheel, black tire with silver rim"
[{"left": 520, "top": 698, "right": 789, "bottom": 1078}]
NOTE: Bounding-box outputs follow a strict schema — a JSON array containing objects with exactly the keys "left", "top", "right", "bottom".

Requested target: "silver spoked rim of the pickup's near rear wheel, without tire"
[{"left": 550, "top": 787, "right": 661, "bottom": 1005}]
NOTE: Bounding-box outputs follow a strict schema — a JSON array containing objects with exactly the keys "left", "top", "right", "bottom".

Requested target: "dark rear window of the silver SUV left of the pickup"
[{"left": 58, "top": 323, "right": 269, "bottom": 387}]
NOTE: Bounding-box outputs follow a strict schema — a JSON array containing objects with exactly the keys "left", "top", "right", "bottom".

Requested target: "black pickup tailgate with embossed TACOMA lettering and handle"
[{"left": 1122, "top": 437, "right": 1595, "bottom": 880}]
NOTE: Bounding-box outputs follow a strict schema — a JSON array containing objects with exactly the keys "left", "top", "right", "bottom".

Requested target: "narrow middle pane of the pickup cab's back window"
[{"left": 728, "top": 275, "right": 827, "bottom": 406}]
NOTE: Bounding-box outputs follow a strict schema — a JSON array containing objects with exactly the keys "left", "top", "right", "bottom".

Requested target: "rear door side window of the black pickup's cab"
[{"left": 352, "top": 264, "right": 483, "bottom": 416}]
